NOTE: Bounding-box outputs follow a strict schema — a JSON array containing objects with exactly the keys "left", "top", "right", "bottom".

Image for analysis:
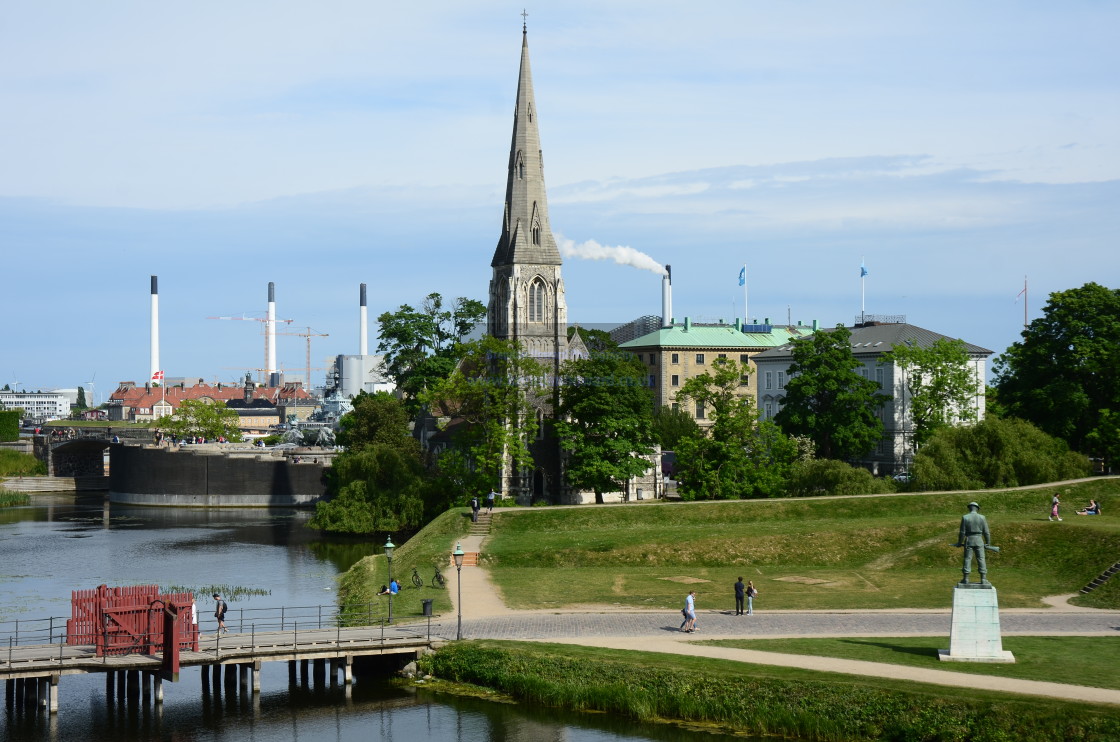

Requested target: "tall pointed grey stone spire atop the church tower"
[{"left": 491, "top": 25, "right": 560, "bottom": 268}]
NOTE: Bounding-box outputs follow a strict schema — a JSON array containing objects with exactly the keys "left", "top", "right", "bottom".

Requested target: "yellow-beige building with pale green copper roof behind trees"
[{"left": 619, "top": 317, "right": 816, "bottom": 426}]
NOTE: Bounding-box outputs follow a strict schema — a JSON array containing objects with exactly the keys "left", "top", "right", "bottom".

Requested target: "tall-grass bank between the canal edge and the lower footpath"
[{"left": 421, "top": 641, "right": 1120, "bottom": 742}]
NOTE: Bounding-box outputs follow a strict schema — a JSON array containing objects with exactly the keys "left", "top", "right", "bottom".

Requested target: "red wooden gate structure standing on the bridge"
[{"left": 66, "top": 585, "right": 198, "bottom": 670}]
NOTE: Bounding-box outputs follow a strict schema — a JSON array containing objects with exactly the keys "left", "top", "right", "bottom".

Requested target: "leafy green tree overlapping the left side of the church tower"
[{"left": 420, "top": 335, "right": 550, "bottom": 498}]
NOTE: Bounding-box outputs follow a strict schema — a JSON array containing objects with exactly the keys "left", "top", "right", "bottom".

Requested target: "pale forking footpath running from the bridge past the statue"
[{"left": 445, "top": 526, "right": 1120, "bottom": 705}]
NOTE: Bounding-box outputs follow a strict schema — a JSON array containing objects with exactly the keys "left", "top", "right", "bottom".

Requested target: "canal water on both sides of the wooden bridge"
[{"left": 0, "top": 497, "right": 746, "bottom": 742}]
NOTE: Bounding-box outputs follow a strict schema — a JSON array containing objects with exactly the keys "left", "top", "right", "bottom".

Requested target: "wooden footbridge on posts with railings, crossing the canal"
[{"left": 0, "top": 605, "right": 442, "bottom": 713}]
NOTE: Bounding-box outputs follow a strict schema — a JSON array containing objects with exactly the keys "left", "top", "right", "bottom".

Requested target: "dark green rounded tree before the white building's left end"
[{"left": 774, "top": 325, "right": 890, "bottom": 458}]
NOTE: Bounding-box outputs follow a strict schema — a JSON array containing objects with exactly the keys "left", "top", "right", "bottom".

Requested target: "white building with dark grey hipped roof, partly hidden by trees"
[{"left": 754, "top": 321, "right": 991, "bottom": 474}]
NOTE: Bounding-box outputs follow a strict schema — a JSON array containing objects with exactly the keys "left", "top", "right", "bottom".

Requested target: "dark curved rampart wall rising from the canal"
[{"left": 109, "top": 445, "right": 327, "bottom": 508}]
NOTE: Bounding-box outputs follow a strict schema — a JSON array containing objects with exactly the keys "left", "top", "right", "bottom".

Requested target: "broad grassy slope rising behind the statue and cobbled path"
[{"left": 483, "top": 479, "right": 1120, "bottom": 610}]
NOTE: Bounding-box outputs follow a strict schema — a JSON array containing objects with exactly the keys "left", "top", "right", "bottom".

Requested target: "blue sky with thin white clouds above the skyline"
[{"left": 0, "top": 0, "right": 1120, "bottom": 397}]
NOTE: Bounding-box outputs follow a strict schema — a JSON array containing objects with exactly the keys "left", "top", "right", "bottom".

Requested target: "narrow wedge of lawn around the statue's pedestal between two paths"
[{"left": 694, "top": 637, "right": 1120, "bottom": 690}]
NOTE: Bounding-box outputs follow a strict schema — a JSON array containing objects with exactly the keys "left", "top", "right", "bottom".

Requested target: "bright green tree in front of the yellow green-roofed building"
[{"left": 676, "top": 359, "right": 797, "bottom": 500}]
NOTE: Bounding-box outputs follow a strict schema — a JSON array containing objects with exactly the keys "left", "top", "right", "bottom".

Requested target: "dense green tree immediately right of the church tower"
[{"left": 556, "top": 350, "right": 653, "bottom": 503}]
